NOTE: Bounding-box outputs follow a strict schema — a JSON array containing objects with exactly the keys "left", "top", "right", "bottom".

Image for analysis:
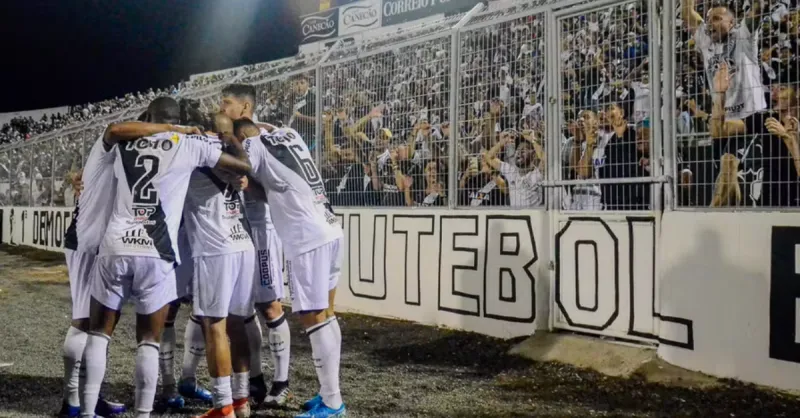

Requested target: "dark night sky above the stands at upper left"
[{"left": 0, "top": 0, "right": 332, "bottom": 112}]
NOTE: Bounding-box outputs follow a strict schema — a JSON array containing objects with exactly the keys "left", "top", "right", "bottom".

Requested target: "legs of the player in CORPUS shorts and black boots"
[{"left": 248, "top": 229, "right": 291, "bottom": 406}]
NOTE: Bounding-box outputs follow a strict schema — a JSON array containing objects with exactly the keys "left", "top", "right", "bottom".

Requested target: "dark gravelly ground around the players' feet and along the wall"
[{"left": 0, "top": 251, "right": 800, "bottom": 418}]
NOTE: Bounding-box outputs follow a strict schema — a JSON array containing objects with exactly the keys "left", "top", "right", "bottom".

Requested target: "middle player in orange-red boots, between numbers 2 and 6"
[{"left": 183, "top": 114, "right": 255, "bottom": 418}]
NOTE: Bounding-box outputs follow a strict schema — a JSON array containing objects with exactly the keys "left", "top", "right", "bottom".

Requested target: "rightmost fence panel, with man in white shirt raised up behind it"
[{"left": 671, "top": 0, "right": 800, "bottom": 209}]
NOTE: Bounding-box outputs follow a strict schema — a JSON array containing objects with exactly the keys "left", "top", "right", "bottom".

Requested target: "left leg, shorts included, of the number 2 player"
[{"left": 80, "top": 256, "right": 128, "bottom": 417}]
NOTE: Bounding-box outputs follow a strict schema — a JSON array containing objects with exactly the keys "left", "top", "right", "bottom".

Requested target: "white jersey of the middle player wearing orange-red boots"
[{"left": 183, "top": 136, "right": 253, "bottom": 257}]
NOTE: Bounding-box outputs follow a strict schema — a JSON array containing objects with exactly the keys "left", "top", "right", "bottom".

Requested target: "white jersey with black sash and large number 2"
[{"left": 100, "top": 132, "right": 222, "bottom": 263}]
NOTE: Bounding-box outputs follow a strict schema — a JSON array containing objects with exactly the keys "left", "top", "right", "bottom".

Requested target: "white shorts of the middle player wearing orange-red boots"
[{"left": 192, "top": 250, "right": 255, "bottom": 318}]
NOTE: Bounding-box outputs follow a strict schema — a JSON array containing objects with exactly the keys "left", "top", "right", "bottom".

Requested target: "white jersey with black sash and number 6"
[{"left": 244, "top": 128, "right": 343, "bottom": 258}]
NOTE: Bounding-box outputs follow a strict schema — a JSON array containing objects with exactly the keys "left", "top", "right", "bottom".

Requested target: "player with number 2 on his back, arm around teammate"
[{"left": 81, "top": 97, "right": 250, "bottom": 418}]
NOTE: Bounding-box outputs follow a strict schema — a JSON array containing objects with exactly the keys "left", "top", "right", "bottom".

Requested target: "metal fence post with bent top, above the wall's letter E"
[{"left": 447, "top": 3, "right": 486, "bottom": 209}]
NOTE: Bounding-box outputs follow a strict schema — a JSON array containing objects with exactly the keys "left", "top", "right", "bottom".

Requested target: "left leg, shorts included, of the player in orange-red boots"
[{"left": 192, "top": 254, "right": 235, "bottom": 418}]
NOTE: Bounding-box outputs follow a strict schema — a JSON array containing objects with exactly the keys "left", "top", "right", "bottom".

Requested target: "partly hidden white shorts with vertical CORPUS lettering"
[{"left": 253, "top": 227, "right": 285, "bottom": 303}]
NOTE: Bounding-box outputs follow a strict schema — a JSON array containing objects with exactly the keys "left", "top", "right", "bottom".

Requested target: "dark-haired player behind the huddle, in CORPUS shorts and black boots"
[{"left": 220, "top": 84, "right": 291, "bottom": 406}]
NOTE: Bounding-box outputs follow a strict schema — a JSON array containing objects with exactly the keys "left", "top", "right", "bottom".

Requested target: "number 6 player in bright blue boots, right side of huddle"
[{"left": 234, "top": 119, "right": 346, "bottom": 418}]
